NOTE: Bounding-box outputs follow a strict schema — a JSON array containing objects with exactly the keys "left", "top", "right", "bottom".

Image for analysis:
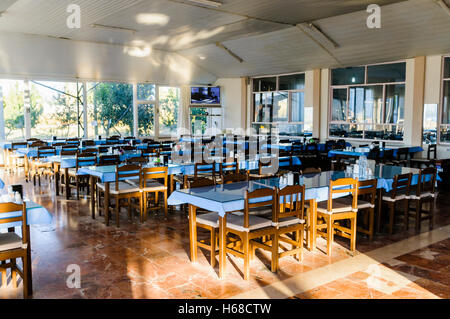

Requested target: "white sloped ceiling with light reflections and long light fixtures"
[{"left": 0, "top": 0, "right": 450, "bottom": 80}]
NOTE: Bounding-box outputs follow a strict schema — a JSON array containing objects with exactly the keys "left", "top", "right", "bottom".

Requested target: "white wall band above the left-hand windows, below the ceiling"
[{"left": 0, "top": 33, "right": 216, "bottom": 85}]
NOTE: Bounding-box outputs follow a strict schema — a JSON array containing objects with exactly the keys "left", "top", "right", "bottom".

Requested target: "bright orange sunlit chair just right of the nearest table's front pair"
[{"left": 314, "top": 178, "right": 358, "bottom": 256}]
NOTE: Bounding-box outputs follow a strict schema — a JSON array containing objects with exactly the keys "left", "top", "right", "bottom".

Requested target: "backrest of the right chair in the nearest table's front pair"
[{"left": 273, "top": 185, "right": 305, "bottom": 223}]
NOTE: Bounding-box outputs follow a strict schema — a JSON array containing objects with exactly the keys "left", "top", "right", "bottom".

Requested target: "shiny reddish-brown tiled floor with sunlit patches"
[{"left": 0, "top": 171, "right": 450, "bottom": 298}]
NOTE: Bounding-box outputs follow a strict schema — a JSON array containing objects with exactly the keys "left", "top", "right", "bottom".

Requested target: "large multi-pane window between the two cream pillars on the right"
[{"left": 329, "top": 62, "right": 406, "bottom": 140}]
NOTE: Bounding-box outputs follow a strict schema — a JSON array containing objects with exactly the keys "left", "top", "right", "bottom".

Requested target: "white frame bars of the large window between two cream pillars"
[{"left": 327, "top": 60, "right": 406, "bottom": 144}]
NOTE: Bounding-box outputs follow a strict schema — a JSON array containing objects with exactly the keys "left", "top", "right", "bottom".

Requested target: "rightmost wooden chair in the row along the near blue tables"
[{"left": 406, "top": 167, "right": 436, "bottom": 232}]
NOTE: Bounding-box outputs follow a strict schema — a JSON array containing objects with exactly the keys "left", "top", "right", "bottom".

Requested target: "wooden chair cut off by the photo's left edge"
[{"left": 0, "top": 203, "right": 32, "bottom": 298}]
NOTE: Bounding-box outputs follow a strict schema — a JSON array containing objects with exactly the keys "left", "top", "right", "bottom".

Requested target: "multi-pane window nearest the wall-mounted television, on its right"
[{"left": 252, "top": 73, "right": 313, "bottom": 136}]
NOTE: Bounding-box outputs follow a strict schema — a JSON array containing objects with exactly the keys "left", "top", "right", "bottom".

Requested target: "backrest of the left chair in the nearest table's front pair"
[{"left": 244, "top": 188, "right": 277, "bottom": 228}]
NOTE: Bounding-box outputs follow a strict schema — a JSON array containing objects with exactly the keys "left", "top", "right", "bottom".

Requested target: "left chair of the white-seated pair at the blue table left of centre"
[{"left": 97, "top": 165, "right": 143, "bottom": 227}]
